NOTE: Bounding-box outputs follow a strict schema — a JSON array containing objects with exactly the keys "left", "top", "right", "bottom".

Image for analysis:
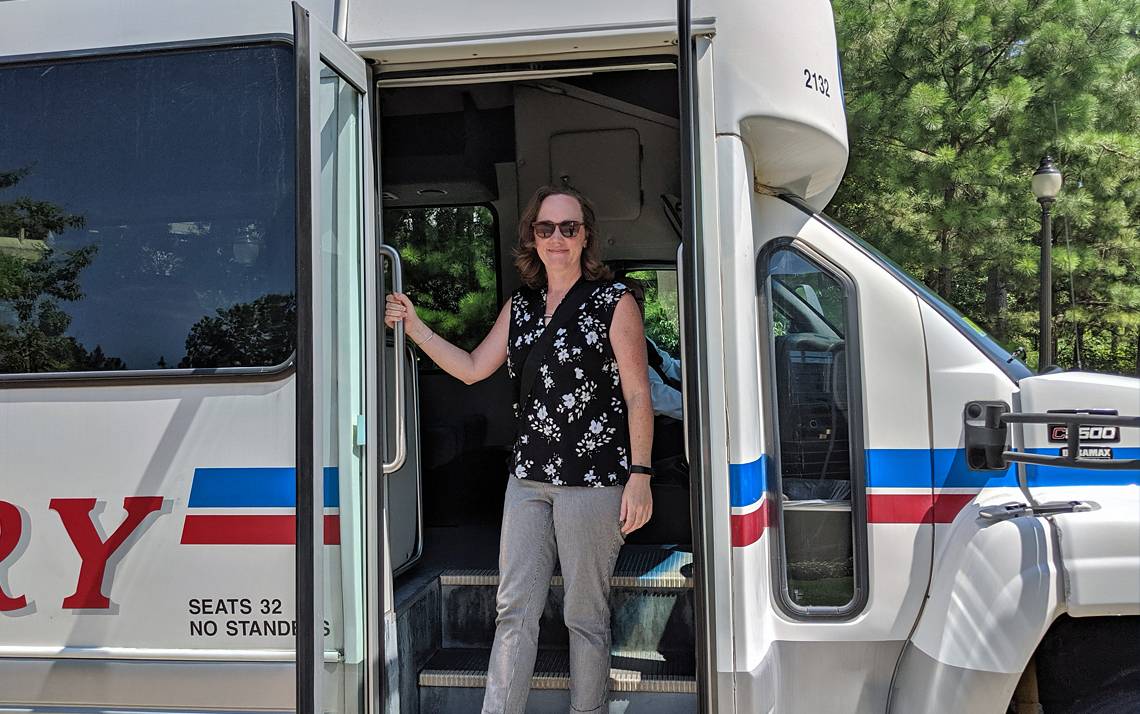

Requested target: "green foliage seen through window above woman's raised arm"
[{"left": 384, "top": 206, "right": 499, "bottom": 350}]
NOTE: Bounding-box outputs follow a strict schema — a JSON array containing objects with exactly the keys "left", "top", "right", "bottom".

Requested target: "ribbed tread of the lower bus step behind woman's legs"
[{"left": 420, "top": 649, "right": 697, "bottom": 693}]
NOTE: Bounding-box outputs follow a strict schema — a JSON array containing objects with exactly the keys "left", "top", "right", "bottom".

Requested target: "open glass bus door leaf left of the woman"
[{"left": 294, "top": 5, "right": 391, "bottom": 714}]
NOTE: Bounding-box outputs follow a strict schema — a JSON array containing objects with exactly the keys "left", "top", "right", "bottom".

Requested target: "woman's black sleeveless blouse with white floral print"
[{"left": 506, "top": 282, "right": 629, "bottom": 487}]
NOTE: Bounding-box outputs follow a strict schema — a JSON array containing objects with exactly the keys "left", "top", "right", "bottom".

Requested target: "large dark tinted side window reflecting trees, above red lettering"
[{"left": 0, "top": 46, "right": 295, "bottom": 373}]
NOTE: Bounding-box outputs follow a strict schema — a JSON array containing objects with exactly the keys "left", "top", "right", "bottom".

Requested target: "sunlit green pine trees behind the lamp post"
[{"left": 831, "top": 0, "right": 1140, "bottom": 373}]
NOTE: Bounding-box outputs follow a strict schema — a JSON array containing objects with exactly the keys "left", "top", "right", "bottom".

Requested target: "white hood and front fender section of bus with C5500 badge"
[{"left": 891, "top": 326, "right": 1140, "bottom": 712}]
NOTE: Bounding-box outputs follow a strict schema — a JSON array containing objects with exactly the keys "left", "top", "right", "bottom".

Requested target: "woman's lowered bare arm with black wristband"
[{"left": 610, "top": 293, "right": 653, "bottom": 534}]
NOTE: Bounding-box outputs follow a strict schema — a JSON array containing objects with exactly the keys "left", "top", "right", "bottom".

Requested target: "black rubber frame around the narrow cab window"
[{"left": 756, "top": 237, "right": 870, "bottom": 620}]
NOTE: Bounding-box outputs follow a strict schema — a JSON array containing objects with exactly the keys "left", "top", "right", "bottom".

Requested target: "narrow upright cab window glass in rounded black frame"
[{"left": 767, "top": 249, "right": 855, "bottom": 614}]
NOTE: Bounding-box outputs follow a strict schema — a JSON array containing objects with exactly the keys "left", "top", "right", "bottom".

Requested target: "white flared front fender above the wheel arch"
[{"left": 890, "top": 489, "right": 1062, "bottom": 714}]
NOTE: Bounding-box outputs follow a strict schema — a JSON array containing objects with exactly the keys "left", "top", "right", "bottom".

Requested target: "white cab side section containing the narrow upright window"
[{"left": 734, "top": 191, "right": 941, "bottom": 712}]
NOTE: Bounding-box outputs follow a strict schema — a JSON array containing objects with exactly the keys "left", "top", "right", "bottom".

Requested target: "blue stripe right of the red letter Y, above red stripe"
[{"left": 189, "top": 466, "right": 341, "bottom": 509}]
